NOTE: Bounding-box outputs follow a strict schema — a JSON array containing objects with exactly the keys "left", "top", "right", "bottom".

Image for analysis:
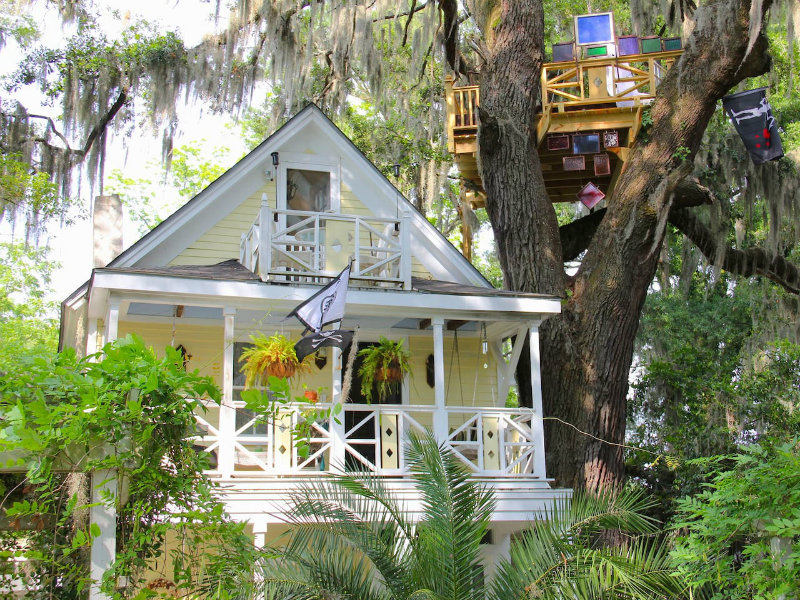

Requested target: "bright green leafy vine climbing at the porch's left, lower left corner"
[{"left": 0, "top": 336, "right": 252, "bottom": 597}]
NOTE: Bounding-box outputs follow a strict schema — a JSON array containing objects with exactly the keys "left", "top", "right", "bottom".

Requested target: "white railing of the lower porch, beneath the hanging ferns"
[{"left": 197, "top": 402, "right": 541, "bottom": 478}]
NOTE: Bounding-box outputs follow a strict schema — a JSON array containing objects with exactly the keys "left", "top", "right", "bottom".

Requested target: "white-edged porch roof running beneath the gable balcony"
[{"left": 69, "top": 260, "right": 561, "bottom": 336}]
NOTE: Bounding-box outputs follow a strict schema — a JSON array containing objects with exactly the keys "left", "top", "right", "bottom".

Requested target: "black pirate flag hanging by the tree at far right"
[{"left": 722, "top": 88, "right": 783, "bottom": 165}]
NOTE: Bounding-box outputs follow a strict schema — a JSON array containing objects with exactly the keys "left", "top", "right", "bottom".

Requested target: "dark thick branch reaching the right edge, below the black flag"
[{"left": 669, "top": 208, "right": 800, "bottom": 294}]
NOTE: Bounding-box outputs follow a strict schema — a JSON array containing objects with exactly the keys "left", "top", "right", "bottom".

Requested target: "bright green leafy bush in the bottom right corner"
[{"left": 673, "top": 439, "right": 800, "bottom": 600}]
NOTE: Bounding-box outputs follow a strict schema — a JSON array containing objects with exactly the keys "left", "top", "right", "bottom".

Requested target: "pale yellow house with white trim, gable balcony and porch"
[{"left": 61, "top": 105, "right": 568, "bottom": 598}]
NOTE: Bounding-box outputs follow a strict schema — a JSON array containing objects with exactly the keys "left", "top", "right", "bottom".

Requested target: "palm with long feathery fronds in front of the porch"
[{"left": 236, "top": 435, "right": 679, "bottom": 600}]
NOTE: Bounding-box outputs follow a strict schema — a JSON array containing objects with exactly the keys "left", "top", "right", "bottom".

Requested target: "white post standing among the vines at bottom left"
[{"left": 89, "top": 469, "right": 117, "bottom": 600}]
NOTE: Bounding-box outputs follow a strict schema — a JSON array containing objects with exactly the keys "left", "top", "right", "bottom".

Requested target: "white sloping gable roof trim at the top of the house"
[{"left": 108, "top": 104, "right": 492, "bottom": 288}]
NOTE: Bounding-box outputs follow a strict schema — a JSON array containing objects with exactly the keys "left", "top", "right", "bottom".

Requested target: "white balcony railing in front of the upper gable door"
[{"left": 239, "top": 198, "right": 411, "bottom": 289}]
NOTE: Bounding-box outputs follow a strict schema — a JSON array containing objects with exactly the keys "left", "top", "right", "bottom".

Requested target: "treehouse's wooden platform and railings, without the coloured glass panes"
[{"left": 446, "top": 50, "right": 683, "bottom": 208}]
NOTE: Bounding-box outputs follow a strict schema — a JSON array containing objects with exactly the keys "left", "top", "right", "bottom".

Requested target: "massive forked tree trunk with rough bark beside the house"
[{"left": 478, "top": 0, "right": 770, "bottom": 491}]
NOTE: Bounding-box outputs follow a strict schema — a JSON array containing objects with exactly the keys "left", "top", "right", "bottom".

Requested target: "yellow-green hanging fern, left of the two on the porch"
[{"left": 240, "top": 333, "right": 311, "bottom": 388}]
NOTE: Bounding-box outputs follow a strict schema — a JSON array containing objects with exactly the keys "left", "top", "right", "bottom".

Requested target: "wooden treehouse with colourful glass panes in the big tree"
[{"left": 446, "top": 13, "right": 682, "bottom": 252}]
